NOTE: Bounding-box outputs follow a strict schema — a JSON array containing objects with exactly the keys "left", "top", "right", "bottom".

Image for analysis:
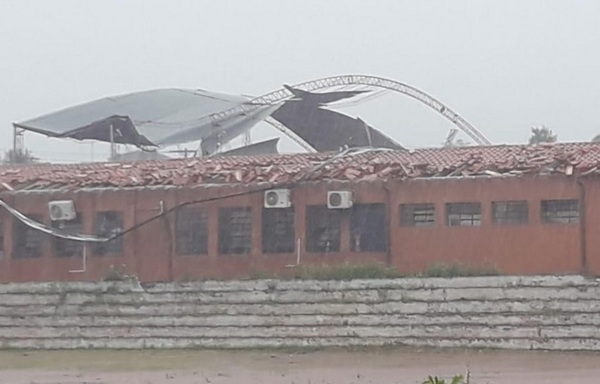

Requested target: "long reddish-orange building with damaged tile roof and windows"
[{"left": 0, "top": 143, "right": 600, "bottom": 282}]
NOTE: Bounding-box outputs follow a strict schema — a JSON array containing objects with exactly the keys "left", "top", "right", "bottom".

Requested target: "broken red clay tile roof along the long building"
[{"left": 0, "top": 143, "right": 600, "bottom": 190}]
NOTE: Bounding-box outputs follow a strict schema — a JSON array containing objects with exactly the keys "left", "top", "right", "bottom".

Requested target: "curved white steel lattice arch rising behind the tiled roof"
[{"left": 209, "top": 75, "right": 491, "bottom": 151}]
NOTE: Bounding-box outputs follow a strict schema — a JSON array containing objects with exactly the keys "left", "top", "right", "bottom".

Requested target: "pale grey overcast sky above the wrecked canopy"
[{"left": 0, "top": 0, "right": 600, "bottom": 161}]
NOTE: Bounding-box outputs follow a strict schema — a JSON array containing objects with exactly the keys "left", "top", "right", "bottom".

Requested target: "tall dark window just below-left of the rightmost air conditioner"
[{"left": 306, "top": 205, "right": 342, "bottom": 252}]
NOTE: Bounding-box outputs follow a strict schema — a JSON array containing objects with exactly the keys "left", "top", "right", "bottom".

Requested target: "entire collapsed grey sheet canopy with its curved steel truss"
[{"left": 13, "top": 75, "right": 489, "bottom": 155}]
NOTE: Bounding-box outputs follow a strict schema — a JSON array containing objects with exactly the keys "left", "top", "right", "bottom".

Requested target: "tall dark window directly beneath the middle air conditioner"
[{"left": 262, "top": 208, "right": 296, "bottom": 253}]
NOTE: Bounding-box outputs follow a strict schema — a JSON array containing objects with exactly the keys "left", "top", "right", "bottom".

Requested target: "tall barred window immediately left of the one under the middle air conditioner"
[{"left": 219, "top": 207, "right": 252, "bottom": 255}]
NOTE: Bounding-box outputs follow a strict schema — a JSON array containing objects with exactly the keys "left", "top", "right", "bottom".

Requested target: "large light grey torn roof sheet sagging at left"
[{"left": 14, "top": 89, "right": 247, "bottom": 146}]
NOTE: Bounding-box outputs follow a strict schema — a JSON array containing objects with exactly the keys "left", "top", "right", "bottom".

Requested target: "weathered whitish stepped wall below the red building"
[{"left": 0, "top": 276, "right": 600, "bottom": 350}]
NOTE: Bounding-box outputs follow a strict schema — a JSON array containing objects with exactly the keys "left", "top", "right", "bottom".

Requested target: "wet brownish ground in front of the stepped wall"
[{"left": 0, "top": 349, "right": 600, "bottom": 384}]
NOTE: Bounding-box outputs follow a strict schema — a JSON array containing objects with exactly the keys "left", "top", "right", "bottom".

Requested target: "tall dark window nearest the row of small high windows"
[{"left": 350, "top": 204, "right": 388, "bottom": 252}]
